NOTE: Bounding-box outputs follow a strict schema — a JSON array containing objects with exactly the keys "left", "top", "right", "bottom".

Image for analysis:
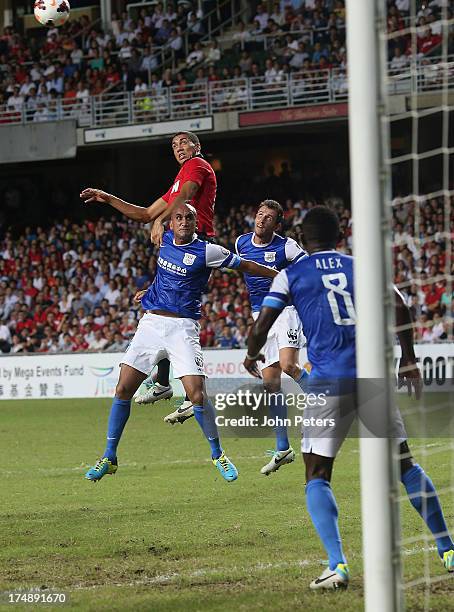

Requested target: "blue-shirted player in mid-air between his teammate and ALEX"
[{"left": 235, "top": 200, "right": 304, "bottom": 476}]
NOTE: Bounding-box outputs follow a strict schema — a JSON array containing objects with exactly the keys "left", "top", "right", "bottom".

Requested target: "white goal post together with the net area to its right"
[{"left": 346, "top": 0, "right": 454, "bottom": 612}]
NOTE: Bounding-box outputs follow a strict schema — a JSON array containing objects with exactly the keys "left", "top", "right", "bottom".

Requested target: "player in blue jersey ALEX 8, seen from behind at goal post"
[{"left": 244, "top": 206, "right": 454, "bottom": 589}]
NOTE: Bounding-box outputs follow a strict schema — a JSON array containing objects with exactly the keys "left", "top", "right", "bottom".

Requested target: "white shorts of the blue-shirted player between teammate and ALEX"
[{"left": 252, "top": 306, "right": 304, "bottom": 370}]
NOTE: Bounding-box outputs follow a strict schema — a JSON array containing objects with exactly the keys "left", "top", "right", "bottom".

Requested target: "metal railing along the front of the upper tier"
[{"left": 0, "top": 56, "right": 454, "bottom": 127}]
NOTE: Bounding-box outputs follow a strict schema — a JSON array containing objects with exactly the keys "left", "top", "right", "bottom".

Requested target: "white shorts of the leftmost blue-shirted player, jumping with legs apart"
[{"left": 121, "top": 313, "right": 205, "bottom": 378}]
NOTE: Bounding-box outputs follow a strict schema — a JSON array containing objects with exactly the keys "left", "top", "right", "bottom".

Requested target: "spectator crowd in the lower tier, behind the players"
[{"left": 0, "top": 186, "right": 454, "bottom": 353}]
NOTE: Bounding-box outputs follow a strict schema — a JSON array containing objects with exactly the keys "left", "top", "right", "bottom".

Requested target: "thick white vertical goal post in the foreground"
[{"left": 346, "top": 0, "right": 400, "bottom": 612}]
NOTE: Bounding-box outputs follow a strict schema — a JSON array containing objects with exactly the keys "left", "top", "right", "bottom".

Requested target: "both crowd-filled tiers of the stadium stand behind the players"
[{"left": 0, "top": 0, "right": 454, "bottom": 353}]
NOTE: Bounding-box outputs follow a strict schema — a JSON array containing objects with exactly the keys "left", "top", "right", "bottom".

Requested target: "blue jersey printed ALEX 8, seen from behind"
[{"left": 263, "top": 251, "right": 356, "bottom": 380}]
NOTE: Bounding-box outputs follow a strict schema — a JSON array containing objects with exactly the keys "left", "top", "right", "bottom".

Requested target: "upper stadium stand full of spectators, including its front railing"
[{"left": 0, "top": 0, "right": 453, "bottom": 124}]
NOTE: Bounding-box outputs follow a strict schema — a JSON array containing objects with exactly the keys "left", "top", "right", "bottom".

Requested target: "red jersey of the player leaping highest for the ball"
[{"left": 162, "top": 156, "right": 217, "bottom": 236}]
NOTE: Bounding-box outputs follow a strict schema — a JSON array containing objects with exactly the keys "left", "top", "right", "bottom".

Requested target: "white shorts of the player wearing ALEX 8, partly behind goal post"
[{"left": 301, "top": 395, "right": 407, "bottom": 457}]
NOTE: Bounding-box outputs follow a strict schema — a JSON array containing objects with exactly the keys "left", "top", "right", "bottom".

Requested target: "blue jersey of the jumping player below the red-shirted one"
[{"left": 142, "top": 231, "right": 241, "bottom": 319}]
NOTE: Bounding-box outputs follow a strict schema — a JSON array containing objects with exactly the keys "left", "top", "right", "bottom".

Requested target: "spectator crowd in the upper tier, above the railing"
[{"left": 0, "top": 0, "right": 452, "bottom": 123}]
